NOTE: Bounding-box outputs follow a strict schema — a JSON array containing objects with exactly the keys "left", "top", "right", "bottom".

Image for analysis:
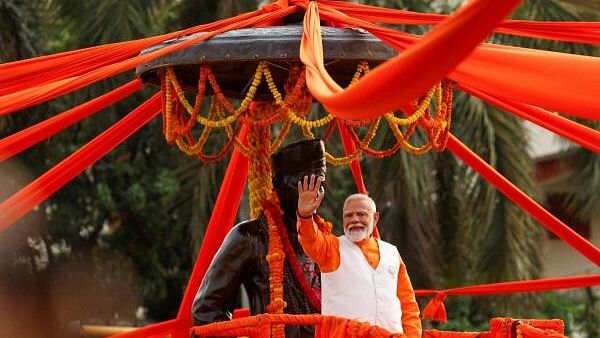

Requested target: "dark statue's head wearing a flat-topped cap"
[{"left": 271, "top": 140, "right": 325, "bottom": 211}]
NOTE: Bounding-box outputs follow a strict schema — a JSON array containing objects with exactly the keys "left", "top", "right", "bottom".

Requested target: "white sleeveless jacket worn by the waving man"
[{"left": 321, "top": 236, "right": 403, "bottom": 333}]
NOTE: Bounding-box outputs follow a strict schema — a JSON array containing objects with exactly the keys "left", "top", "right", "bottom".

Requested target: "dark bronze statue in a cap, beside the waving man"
[{"left": 192, "top": 140, "right": 325, "bottom": 337}]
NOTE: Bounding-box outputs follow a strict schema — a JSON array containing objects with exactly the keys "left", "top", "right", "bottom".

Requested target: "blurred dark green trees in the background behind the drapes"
[{"left": 0, "top": 0, "right": 600, "bottom": 337}]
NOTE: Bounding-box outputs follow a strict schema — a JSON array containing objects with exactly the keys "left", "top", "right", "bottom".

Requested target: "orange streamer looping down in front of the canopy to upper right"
[{"left": 300, "top": 0, "right": 520, "bottom": 119}]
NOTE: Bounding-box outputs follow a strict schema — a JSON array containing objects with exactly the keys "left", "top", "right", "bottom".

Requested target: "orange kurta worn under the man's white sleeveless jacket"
[{"left": 298, "top": 217, "right": 421, "bottom": 338}]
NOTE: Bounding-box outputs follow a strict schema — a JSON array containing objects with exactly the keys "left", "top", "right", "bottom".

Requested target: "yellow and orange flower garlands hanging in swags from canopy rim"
[{"left": 160, "top": 61, "right": 454, "bottom": 165}]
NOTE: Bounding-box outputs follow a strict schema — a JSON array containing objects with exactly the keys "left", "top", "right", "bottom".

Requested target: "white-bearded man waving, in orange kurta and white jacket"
[{"left": 297, "top": 175, "right": 421, "bottom": 338}]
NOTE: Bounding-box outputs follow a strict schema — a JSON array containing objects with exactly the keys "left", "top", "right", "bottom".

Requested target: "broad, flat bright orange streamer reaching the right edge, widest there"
[{"left": 450, "top": 45, "right": 600, "bottom": 120}]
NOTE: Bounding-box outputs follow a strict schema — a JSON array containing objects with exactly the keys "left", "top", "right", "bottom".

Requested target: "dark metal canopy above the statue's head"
[{"left": 136, "top": 25, "right": 397, "bottom": 99}]
